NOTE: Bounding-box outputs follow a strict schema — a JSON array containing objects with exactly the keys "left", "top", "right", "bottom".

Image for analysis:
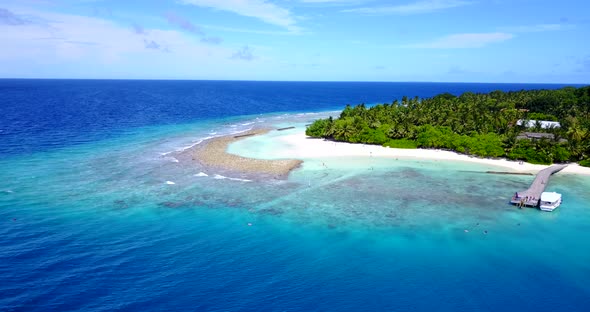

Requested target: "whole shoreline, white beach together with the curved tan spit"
[{"left": 176, "top": 127, "right": 590, "bottom": 179}]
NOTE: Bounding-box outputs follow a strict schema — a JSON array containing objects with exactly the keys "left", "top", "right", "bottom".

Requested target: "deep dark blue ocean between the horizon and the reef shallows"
[{"left": 0, "top": 79, "right": 584, "bottom": 156}]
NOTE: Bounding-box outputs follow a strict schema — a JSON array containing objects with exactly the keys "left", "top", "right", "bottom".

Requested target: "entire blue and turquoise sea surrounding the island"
[{"left": 0, "top": 79, "right": 590, "bottom": 311}]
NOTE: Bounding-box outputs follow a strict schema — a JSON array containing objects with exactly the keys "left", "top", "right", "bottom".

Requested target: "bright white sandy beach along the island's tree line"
[{"left": 264, "top": 129, "right": 590, "bottom": 175}]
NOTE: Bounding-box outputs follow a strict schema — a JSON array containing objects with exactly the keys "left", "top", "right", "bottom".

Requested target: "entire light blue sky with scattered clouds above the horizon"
[{"left": 0, "top": 0, "right": 590, "bottom": 84}]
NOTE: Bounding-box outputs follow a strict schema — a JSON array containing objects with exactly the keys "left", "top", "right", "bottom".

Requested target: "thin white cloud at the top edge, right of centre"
[{"left": 343, "top": 0, "right": 473, "bottom": 15}]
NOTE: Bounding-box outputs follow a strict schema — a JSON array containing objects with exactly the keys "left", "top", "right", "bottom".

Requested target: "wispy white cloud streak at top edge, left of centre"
[{"left": 180, "top": 0, "right": 299, "bottom": 31}]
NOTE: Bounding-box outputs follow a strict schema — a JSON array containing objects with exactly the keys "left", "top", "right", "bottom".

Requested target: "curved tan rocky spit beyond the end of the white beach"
[{"left": 177, "top": 129, "right": 303, "bottom": 179}]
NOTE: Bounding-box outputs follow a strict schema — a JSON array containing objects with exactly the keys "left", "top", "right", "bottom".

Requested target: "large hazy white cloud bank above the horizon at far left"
[{"left": 0, "top": 10, "right": 243, "bottom": 77}]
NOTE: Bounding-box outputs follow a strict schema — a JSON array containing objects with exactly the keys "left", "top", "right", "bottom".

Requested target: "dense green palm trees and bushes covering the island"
[{"left": 306, "top": 86, "right": 590, "bottom": 166}]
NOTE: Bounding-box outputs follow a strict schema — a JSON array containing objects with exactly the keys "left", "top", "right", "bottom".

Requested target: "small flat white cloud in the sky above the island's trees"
[{"left": 405, "top": 32, "right": 514, "bottom": 49}]
